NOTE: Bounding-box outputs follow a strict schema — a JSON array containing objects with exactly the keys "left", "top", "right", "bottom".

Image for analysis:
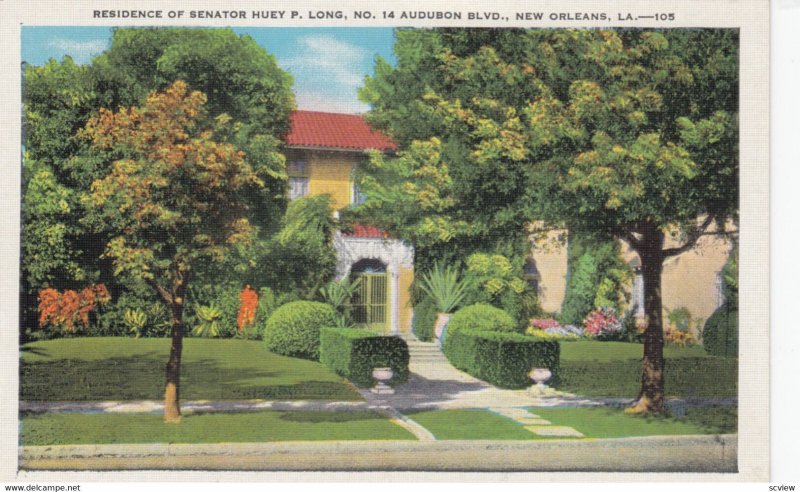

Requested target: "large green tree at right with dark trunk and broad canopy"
[{"left": 363, "top": 30, "right": 738, "bottom": 412}]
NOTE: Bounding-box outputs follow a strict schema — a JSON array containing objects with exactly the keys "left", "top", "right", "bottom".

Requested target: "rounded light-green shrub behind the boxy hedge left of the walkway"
[{"left": 263, "top": 301, "right": 337, "bottom": 360}]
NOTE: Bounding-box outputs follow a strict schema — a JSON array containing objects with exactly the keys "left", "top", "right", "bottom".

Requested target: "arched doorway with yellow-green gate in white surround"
[{"left": 350, "top": 258, "right": 389, "bottom": 331}]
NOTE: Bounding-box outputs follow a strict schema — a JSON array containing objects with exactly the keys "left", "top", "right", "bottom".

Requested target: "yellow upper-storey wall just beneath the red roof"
[{"left": 307, "top": 152, "right": 356, "bottom": 210}]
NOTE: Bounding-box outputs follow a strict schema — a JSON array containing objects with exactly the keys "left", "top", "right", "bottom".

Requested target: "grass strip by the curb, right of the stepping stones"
[{"left": 531, "top": 407, "right": 737, "bottom": 438}]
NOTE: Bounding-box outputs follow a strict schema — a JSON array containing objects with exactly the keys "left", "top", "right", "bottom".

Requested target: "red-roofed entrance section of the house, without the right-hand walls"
[{"left": 285, "top": 111, "right": 414, "bottom": 334}]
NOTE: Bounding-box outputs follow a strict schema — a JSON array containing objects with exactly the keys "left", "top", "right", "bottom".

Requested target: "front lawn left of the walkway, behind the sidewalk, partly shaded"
[{"left": 20, "top": 337, "right": 361, "bottom": 401}]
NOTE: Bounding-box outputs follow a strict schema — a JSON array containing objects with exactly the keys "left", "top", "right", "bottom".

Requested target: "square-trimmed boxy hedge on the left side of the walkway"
[{"left": 319, "top": 327, "right": 409, "bottom": 386}]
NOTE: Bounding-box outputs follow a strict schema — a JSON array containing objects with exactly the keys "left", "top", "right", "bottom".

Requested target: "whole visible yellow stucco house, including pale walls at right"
[{"left": 285, "top": 111, "right": 732, "bottom": 334}]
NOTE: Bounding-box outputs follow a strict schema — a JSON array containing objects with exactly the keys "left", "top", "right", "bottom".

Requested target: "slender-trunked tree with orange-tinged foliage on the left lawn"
[{"left": 82, "top": 81, "right": 263, "bottom": 422}]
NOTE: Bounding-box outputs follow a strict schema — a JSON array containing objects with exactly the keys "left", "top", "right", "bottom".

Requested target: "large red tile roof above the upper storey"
[{"left": 285, "top": 111, "right": 397, "bottom": 150}]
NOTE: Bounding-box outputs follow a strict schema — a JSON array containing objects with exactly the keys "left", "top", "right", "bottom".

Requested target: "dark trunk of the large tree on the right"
[{"left": 626, "top": 228, "right": 664, "bottom": 413}]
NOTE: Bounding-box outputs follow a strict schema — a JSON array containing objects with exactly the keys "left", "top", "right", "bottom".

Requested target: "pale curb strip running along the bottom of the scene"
[{"left": 19, "top": 434, "right": 738, "bottom": 473}]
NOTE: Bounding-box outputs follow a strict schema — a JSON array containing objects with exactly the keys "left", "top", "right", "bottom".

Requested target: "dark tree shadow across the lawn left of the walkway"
[{"left": 20, "top": 352, "right": 359, "bottom": 401}]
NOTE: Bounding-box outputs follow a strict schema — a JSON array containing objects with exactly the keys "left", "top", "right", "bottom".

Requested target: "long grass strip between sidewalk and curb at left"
[{"left": 22, "top": 411, "right": 415, "bottom": 446}]
